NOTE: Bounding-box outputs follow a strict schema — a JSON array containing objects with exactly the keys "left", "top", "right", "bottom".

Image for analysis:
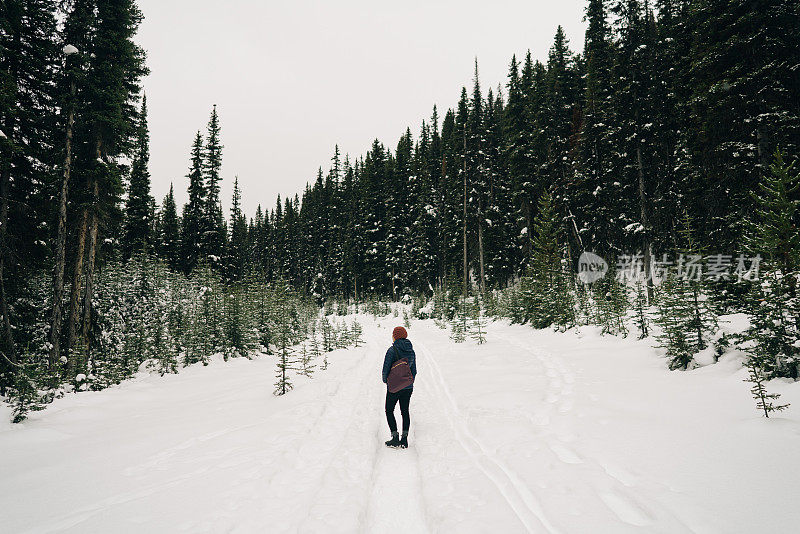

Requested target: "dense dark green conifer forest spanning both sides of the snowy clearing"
[{"left": 0, "top": 0, "right": 800, "bottom": 418}]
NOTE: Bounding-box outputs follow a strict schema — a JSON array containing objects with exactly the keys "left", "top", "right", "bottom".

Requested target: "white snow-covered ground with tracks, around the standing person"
[{"left": 0, "top": 316, "right": 800, "bottom": 534}]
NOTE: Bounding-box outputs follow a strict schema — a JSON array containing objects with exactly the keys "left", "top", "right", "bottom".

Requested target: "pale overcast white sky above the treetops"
[{"left": 137, "top": 0, "right": 586, "bottom": 216}]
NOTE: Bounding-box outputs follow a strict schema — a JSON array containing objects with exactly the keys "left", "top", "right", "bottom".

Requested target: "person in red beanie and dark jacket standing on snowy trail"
[{"left": 383, "top": 326, "right": 417, "bottom": 449}]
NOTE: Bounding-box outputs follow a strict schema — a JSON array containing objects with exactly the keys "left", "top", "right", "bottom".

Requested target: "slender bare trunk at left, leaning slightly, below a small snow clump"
[{"left": 48, "top": 80, "right": 75, "bottom": 369}]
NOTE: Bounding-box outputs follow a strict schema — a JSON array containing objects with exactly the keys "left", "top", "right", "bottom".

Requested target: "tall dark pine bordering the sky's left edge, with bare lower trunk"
[{"left": 68, "top": 0, "right": 148, "bottom": 374}]
